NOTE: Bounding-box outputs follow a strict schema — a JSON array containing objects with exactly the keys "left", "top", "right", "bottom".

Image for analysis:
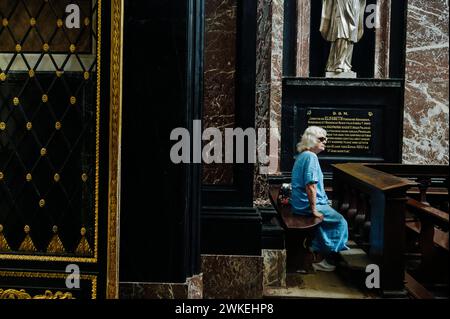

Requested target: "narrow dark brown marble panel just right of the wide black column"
[{"left": 202, "top": 0, "right": 237, "bottom": 185}]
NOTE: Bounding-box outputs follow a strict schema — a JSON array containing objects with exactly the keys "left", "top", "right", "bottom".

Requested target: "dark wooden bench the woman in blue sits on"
[{"left": 269, "top": 184, "right": 322, "bottom": 272}]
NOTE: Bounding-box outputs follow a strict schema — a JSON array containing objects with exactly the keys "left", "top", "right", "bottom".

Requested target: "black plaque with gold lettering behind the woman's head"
[{"left": 306, "top": 108, "right": 381, "bottom": 156}]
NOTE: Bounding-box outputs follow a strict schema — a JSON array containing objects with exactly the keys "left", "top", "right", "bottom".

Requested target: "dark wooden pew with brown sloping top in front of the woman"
[{"left": 332, "top": 163, "right": 417, "bottom": 296}]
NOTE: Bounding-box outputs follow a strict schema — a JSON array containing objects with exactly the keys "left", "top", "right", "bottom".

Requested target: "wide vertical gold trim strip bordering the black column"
[{"left": 107, "top": 0, "right": 124, "bottom": 298}]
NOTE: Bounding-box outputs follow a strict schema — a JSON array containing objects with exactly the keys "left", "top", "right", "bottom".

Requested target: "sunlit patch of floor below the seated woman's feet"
[{"left": 264, "top": 272, "right": 377, "bottom": 299}]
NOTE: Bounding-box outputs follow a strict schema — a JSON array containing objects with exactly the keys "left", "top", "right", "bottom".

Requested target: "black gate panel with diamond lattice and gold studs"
[{"left": 0, "top": 0, "right": 98, "bottom": 257}]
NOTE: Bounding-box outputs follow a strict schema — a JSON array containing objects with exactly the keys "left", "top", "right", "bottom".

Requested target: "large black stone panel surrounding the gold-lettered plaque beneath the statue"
[{"left": 280, "top": 78, "right": 404, "bottom": 176}]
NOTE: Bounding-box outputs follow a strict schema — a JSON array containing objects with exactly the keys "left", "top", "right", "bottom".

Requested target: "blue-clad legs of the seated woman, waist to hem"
[{"left": 311, "top": 205, "right": 349, "bottom": 256}]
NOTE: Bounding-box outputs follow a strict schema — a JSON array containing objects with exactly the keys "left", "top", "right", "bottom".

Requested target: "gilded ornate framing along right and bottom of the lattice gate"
[{"left": 0, "top": 0, "right": 124, "bottom": 299}]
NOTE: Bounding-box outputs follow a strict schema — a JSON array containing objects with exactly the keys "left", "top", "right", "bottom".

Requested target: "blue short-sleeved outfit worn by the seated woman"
[{"left": 291, "top": 151, "right": 349, "bottom": 255}]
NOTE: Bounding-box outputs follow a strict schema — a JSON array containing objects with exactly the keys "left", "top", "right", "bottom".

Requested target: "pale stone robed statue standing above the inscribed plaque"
[{"left": 320, "top": 0, "right": 366, "bottom": 78}]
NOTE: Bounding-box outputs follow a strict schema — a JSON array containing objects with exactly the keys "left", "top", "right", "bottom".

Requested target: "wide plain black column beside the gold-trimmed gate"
[{"left": 120, "top": 0, "right": 202, "bottom": 282}]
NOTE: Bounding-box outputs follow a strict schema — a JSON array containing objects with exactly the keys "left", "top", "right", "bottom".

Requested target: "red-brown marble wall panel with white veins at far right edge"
[{"left": 403, "top": 0, "right": 449, "bottom": 164}]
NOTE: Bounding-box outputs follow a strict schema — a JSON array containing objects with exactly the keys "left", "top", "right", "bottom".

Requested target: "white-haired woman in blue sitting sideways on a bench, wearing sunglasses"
[{"left": 291, "top": 126, "right": 349, "bottom": 271}]
